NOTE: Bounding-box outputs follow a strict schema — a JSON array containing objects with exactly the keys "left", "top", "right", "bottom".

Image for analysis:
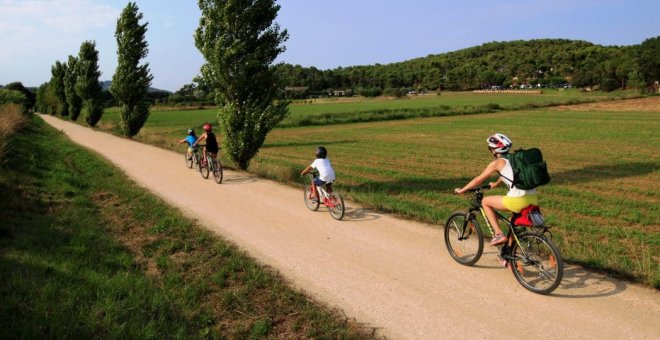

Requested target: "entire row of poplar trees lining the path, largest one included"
[{"left": 38, "top": 0, "right": 289, "bottom": 169}]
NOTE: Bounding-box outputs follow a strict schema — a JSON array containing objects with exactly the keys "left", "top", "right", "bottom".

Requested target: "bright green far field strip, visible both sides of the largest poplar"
[{"left": 101, "top": 90, "right": 637, "bottom": 132}]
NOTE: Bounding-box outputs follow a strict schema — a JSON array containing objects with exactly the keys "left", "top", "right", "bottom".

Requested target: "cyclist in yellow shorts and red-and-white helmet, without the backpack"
[{"left": 454, "top": 133, "right": 539, "bottom": 245}]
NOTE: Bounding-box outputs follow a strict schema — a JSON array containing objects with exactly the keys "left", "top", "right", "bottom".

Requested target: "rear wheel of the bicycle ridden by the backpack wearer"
[{"left": 511, "top": 233, "right": 564, "bottom": 294}]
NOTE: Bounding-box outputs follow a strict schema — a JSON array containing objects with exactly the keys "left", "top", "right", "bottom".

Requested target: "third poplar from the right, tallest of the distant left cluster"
[{"left": 76, "top": 41, "right": 103, "bottom": 126}]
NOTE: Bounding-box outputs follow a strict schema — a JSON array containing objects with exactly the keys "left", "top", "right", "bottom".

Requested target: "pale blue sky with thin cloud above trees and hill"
[{"left": 0, "top": 0, "right": 660, "bottom": 91}]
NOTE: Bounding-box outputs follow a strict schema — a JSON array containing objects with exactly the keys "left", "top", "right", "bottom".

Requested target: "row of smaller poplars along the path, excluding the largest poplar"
[{"left": 37, "top": 2, "right": 153, "bottom": 137}]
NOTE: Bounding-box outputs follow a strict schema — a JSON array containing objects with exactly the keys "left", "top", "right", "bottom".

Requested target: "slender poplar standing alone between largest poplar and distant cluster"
[{"left": 110, "top": 2, "right": 153, "bottom": 137}]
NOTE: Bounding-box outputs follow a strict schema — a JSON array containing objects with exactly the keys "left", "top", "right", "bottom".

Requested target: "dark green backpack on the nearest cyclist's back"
[{"left": 500, "top": 148, "right": 550, "bottom": 190}]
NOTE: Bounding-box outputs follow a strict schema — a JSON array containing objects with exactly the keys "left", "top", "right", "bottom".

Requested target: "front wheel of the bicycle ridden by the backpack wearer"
[{"left": 445, "top": 211, "right": 484, "bottom": 266}]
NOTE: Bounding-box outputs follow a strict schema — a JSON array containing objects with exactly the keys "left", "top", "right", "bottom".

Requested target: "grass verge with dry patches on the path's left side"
[{"left": 0, "top": 117, "right": 373, "bottom": 339}]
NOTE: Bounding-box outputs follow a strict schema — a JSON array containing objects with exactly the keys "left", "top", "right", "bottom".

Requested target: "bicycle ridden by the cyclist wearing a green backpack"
[{"left": 444, "top": 185, "right": 564, "bottom": 295}]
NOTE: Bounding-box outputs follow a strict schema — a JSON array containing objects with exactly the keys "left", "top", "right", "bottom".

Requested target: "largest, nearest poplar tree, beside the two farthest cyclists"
[{"left": 195, "top": 0, "right": 289, "bottom": 169}]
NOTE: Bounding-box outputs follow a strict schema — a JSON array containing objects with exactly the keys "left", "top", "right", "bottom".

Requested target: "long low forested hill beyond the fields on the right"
[{"left": 277, "top": 37, "right": 659, "bottom": 96}]
